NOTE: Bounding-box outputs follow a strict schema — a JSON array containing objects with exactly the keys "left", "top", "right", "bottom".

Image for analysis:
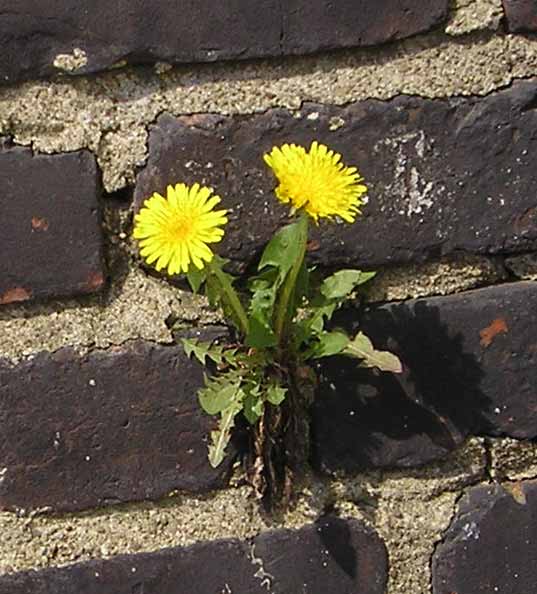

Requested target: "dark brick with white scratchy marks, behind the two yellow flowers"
[{"left": 136, "top": 81, "right": 537, "bottom": 267}]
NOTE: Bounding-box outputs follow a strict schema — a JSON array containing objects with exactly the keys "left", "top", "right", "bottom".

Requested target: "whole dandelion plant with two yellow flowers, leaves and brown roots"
[{"left": 134, "top": 142, "right": 401, "bottom": 502}]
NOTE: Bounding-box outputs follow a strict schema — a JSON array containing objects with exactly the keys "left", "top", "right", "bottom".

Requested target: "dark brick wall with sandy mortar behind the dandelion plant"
[{"left": 0, "top": 0, "right": 537, "bottom": 594}]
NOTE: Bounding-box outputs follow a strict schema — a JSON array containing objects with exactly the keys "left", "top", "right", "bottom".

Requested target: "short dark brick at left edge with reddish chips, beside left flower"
[{"left": 0, "top": 146, "right": 105, "bottom": 305}]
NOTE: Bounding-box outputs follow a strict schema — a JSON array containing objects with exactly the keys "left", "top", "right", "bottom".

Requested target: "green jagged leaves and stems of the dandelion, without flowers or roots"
[{"left": 182, "top": 216, "right": 402, "bottom": 466}]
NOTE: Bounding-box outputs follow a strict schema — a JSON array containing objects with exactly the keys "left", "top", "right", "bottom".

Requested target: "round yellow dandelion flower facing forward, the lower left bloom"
[{"left": 133, "top": 184, "right": 227, "bottom": 275}]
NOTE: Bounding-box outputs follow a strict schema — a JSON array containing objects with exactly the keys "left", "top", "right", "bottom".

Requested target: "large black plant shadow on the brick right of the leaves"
[{"left": 312, "top": 301, "right": 490, "bottom": 473}]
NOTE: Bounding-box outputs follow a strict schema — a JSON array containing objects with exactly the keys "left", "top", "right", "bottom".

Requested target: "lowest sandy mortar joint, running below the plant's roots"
[{"left": 0, "top": 439, "right": 485, "bottom": 594}]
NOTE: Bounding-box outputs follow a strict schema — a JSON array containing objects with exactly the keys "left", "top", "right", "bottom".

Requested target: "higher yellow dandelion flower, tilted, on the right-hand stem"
[{"left": 264, "top": 141, "right": 367, "bottom": 223}]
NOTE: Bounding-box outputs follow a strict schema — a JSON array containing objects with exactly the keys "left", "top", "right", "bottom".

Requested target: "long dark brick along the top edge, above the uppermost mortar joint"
[{"left": 0, "top": 0, "right": 448, "bottom": 82}]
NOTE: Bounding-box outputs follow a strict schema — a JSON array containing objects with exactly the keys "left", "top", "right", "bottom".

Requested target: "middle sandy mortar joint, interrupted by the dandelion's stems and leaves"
[{"left": 0, "top": 250, "right": 503, "bottom": 364}]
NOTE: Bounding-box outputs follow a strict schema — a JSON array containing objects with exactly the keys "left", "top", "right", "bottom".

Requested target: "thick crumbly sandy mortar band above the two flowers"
[{"left": 0, "top": 32, "right": 537, "bottom": 191}]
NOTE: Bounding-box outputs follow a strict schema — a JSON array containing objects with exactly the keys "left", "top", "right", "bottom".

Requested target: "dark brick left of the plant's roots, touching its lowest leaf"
[{"left": 0, "top": 342, "right": 233, "bottom": 510}]
